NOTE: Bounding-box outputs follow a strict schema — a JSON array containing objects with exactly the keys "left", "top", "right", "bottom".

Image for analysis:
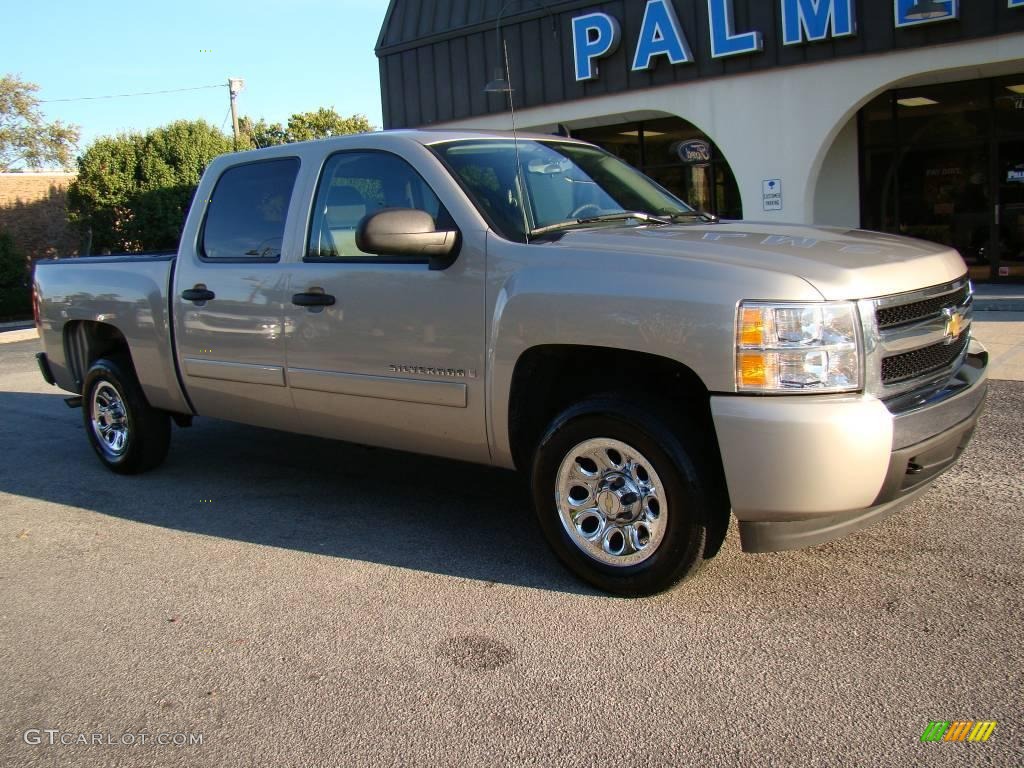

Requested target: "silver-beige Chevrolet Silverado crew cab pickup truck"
[{"left": 35, "top": 131, "right": 987, "bottom": 595}]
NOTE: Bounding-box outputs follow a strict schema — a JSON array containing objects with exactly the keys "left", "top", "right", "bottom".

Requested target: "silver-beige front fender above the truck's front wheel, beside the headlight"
[{"left": 487, "top": 243, "right": 820, "bottom": 466}]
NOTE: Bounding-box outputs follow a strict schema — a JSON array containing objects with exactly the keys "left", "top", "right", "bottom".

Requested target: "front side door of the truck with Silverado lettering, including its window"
[{"left": 285, "top": 150, "right": 487, "bottom": 461}]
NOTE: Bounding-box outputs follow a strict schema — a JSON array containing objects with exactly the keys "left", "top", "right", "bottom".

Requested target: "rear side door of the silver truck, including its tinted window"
[{"left": 172, "top": 158, "right": 299, "bottom": 434}]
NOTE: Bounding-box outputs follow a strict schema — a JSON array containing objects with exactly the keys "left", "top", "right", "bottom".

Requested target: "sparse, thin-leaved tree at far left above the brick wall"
[{"left": 0, "top": 75, "right": 79, "bottom": 171}]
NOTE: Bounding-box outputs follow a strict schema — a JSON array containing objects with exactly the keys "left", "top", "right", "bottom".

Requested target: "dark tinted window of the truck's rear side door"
[{"left": 200, "top": 158, "right": 299, "bottom": 261}]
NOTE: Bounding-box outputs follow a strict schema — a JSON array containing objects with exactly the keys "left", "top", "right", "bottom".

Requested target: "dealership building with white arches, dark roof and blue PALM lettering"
[{"left": 377, "top": 0, "right": 1024, "bottom": 281}]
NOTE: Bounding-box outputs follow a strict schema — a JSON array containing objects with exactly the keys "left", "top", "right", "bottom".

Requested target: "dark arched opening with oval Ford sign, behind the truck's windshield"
[{"left": 572, "top": 118, "right": 743, "bottom": 219}]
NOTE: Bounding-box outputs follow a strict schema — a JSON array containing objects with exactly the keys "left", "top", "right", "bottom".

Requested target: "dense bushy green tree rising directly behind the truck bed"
[{"left": 68, "top": 120, "right": 231, "bottom": 253}]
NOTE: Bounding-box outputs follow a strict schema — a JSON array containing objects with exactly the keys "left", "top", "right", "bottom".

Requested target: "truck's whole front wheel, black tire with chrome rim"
[{"left": 531, "top": 398, "right": 710, "bottom": 597}]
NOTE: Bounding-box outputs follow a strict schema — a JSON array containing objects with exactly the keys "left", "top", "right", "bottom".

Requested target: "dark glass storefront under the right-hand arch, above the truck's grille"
[{"left": 859, "top": 73, "right": 1024, "bottom": 281}]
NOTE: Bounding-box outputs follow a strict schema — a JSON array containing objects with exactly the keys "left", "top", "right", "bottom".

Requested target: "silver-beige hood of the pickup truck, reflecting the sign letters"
[{"left": 552, "top": 221, "right": 967, "bottom": 300}]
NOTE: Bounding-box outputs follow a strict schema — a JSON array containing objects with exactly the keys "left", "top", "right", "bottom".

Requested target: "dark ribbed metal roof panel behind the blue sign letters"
[{"left": 377, "top": 0, "right": 1024, "bottom": 128}]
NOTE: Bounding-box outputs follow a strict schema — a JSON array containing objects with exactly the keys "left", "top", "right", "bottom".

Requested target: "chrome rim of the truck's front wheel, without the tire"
[{"left": 555, "top": 437, "right": 669, "bottom": 567}]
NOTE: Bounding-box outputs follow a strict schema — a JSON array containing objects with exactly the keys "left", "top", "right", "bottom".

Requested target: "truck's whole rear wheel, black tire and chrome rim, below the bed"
[{"left": 82, "top": 356, "right": 171, "bottom": 475}]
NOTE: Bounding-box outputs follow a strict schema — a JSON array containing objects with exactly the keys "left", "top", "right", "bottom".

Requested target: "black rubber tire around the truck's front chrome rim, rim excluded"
[{"left": 530, "top": 397, "right": 716, "bottom": 597}]
